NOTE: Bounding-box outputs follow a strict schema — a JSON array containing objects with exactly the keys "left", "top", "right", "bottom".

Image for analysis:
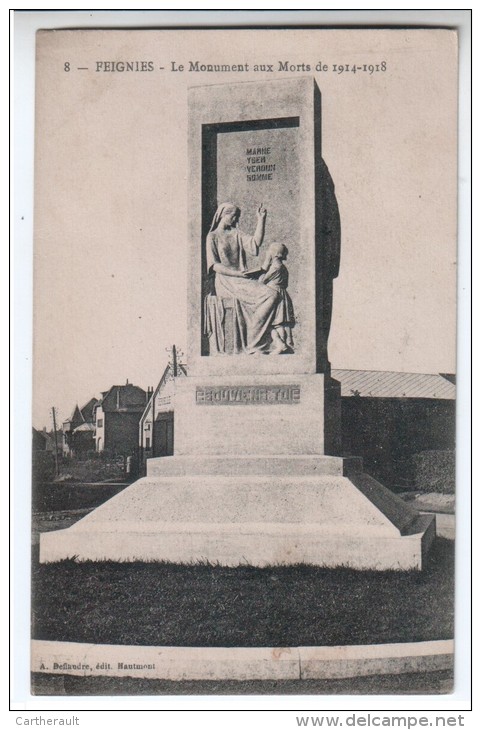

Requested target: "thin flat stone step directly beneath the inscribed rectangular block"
[{"left": 147, "top": 455, "right": 362, "bottom": 477}]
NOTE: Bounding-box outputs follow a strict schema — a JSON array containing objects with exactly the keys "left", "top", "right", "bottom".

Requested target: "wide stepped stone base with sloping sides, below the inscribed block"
[{"left": 40, "top": 456, "right": 435, "bottom": 570}]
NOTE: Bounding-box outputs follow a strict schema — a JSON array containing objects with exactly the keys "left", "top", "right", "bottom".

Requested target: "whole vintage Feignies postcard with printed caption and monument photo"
[{"left": 31, "top": 28, "right": 458, "bottom": 696}]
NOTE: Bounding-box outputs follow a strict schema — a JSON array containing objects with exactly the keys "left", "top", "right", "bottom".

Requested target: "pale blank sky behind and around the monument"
[{"left": 27, "top": 30, "right": 457, "bottom": 427}]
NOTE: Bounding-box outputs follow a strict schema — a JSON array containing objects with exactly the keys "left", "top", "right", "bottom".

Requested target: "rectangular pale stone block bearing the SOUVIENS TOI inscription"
[{"left": 175, "top": 374, "right": 341, "bottom": 458}]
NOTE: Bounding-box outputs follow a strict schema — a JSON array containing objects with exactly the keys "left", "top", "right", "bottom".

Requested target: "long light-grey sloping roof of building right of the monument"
[{"left": 332, "top": 370, "right": 456, "bottom": 400}]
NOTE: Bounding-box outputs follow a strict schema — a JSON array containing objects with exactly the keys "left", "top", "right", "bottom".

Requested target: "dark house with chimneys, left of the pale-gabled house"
[{"left": 94, "top": 380, "right": 146, "bottom": 456}]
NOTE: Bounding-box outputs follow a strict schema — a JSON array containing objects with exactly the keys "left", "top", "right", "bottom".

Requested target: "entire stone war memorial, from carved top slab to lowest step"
[{"left": 40, "top": 78, "right": 435, "bottom": 570}]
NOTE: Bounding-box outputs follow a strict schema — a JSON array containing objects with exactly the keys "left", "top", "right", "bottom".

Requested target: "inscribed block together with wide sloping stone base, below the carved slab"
[{"left": 40, "top": 375, "right": 435, "bottom": 570}]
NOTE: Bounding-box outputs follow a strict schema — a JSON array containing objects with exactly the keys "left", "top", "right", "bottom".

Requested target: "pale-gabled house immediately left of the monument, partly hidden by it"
[{"left": 139, "top": 361, "right": 187, "bottom": 464}]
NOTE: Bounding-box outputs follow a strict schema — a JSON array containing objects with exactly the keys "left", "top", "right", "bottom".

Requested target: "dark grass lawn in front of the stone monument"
[{"left": 32, "top": 538, "right": 454, "bottom": 646}]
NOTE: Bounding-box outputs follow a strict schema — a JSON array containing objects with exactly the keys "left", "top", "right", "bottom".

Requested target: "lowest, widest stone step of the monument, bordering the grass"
[{"left": 40, "top": 506, "right": 435, "bottom": 570}]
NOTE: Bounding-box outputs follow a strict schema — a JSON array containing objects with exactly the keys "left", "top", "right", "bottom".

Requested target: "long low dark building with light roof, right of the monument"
[{"left": 332, "top": 370, "right": 456, "bottom": 491}]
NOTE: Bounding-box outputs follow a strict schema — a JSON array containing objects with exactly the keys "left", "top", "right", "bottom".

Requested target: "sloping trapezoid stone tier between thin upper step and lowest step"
[{"left": 77, "top": 474, "right": 418, "bottom": 535}]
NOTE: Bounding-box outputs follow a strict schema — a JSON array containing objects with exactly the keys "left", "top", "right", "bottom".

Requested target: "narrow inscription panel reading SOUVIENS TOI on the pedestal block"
[{"left": 195, "top": 385, "right": 301, "bottom": 406}]
